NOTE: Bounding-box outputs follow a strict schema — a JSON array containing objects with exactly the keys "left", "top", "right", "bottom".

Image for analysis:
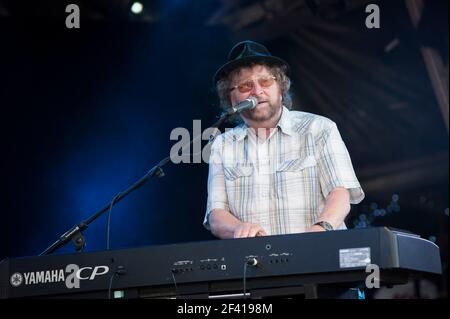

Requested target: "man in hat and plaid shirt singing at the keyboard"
[{"left": 204, "top": 41, "right": 364, "bottom": 238}]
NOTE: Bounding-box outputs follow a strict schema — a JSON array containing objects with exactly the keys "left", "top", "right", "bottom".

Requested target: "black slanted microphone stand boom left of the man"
[{"left": 39, "top": 106, "right": 236, "bottom": 256}]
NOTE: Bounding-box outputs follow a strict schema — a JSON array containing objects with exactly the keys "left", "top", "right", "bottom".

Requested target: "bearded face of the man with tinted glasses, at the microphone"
[{"left": 230, "top": 65, "right": 282, "bottom": 122}]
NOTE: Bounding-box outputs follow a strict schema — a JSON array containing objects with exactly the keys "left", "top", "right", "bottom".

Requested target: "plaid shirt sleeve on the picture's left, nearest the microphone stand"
[{"left": 203, "top": 136, "right": 230, "bottom": 230}]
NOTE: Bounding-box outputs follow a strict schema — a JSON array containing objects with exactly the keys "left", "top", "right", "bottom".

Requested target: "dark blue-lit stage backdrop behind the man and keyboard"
[{"left": 0, "top": 0, "right": 448, "bottom": 295}]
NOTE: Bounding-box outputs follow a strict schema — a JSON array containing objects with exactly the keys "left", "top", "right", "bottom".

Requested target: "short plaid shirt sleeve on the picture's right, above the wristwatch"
[{"left": 317, "top": 122, "right": 365, "bottom": 204}]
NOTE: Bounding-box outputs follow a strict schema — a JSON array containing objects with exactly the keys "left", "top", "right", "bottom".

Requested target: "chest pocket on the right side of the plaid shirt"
[{"left": 275, "top": 155, "right": 318, "bottom": 201}]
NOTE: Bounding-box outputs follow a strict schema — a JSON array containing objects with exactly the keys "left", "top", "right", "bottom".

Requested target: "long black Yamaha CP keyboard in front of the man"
[{"left": 0, "top": 227, "right": 442, "bottom": 298}]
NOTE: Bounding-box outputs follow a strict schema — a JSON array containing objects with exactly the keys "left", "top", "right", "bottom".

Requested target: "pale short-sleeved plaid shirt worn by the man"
[{"left": 203, "top": 107, "right": 364, "bottom": 235}]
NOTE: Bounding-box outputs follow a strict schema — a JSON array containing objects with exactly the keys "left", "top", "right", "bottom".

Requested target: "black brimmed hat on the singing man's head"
[{"left": 213, "top": 40, "right": 289, "bottom": 84}]
